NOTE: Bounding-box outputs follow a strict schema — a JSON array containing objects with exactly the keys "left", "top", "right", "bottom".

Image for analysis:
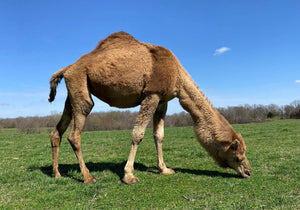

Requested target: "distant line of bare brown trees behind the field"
[{"left": 0, "top": 100, "right": 300, "bottom": 133}]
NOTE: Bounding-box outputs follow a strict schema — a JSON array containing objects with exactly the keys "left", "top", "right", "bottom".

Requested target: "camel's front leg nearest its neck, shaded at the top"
[{"left": 153, "top": 103, "right": 175, "bottom": 175}]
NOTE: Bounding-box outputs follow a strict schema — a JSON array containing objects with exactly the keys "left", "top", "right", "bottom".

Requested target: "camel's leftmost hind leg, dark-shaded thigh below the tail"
[{"left": 50, "top": 97, "right": 72, "bottom": 178}]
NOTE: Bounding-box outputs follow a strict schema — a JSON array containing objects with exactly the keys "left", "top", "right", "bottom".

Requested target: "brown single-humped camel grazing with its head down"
[{"left": 49, "top": 32, "right": 251, "bottom": 184}]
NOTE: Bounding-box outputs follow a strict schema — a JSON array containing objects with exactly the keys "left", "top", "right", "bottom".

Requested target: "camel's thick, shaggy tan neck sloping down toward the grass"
[{"left": 178, "top": 73, "right": 234, "bottom": 146}]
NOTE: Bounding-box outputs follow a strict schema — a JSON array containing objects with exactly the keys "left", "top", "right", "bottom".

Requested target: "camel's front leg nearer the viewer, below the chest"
[{"left": 122, "top": 95, "right": 159, "bottom": 184}]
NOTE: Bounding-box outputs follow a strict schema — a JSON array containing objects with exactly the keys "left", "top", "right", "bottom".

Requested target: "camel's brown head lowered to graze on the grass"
[{"left": 216, "top": 135, "right": 251, "bottom": 178}]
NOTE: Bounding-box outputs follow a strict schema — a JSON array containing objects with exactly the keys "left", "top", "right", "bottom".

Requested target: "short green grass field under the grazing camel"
[{"left": 0, "top": 120, "right": 300, "bottom": 209}]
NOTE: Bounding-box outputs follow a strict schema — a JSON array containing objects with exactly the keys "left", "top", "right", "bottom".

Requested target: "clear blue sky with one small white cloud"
[{"left": 0, "top": 0, "right": 300, "bottom": 118}]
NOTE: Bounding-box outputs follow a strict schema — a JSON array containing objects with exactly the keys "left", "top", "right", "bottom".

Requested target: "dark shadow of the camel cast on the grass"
[{"left": 29, "top": 161, "right": 238, "bottom": 182}]
